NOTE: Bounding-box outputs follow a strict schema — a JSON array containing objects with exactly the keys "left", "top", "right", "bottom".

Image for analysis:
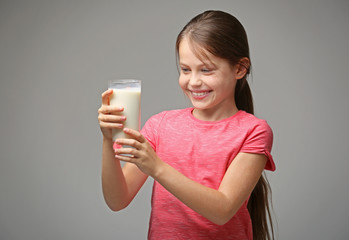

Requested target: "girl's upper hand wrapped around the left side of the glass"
[{"left": 98, "top": 89, "right": 126, "bottom": 141}]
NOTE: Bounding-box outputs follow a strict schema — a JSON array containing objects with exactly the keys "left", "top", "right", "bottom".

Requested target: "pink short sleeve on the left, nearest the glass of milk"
[{"left": 141, "top": 112, "right": 166, "bottom": 151}]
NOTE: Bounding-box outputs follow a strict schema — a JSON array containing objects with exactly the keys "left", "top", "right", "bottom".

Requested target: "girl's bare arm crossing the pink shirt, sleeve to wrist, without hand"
[{"left": 154, "top": 153, "right": 266, "bottom": 225}]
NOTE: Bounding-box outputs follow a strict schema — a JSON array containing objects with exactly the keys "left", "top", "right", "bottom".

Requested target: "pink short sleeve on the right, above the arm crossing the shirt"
[{"left": 240, "top": 120, "right": 275, "bottom": 171}]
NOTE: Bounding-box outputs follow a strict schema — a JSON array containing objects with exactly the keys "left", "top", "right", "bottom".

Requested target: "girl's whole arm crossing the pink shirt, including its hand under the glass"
[{"left": 117, "top": 129, "right": 267, "bottom": 225}]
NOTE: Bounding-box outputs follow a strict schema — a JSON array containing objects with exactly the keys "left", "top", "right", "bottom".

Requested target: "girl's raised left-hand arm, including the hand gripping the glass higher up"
[{"left": 98, "top": 90, "right": 147, "bottom": 211}]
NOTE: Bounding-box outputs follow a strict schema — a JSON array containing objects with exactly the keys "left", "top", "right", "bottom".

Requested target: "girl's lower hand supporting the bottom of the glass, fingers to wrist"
[{"left": 115, "top": 128, "right": 163, "bottom": 177}]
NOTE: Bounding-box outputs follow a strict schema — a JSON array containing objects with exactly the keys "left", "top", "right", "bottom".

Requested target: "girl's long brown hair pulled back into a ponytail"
[{"left": 176, "top": 11, "right": 274, "bottom": 240}]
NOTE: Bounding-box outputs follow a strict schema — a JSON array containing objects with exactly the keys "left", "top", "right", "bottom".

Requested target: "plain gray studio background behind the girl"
[{"left": 0, "top": 0, "right": 349, "bottom": 240}]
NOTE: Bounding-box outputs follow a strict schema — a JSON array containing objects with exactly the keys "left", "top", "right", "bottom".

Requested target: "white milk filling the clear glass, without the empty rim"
[{"left": 110, "top": 87, "right": 141, "bottom": 141}]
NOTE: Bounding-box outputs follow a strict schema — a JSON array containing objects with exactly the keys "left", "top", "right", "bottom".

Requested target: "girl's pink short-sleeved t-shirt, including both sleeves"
[{"left": 142, "top": 108, "right": 275, "bottom": 240}]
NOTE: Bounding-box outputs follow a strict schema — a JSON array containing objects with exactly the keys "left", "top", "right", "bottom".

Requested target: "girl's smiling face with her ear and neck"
[{"left": 178, "top": 38, "right": 241, "bottom": 121}]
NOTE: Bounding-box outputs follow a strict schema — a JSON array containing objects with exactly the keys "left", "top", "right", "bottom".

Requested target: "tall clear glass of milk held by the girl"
[{"left": 108, "top": 79, "right": 141, "bottom": 141}]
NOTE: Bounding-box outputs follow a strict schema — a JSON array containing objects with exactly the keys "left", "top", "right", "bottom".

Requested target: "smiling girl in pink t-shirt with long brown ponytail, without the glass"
[{"left": 98, "top": 11, "right": 275, "bottom": 240}]
